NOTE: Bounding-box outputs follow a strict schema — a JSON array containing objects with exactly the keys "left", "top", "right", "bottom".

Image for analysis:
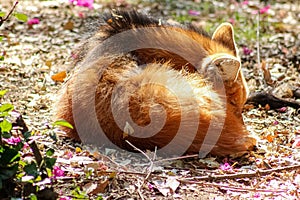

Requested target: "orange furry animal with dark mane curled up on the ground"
[{"left": 55, "top": 11, "right": 255, "bottom": 155}]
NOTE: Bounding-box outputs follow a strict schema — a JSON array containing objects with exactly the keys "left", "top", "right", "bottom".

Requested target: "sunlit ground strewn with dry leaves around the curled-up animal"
[{"left": 0, "top": 0, "right": 300, "bottom": 199}]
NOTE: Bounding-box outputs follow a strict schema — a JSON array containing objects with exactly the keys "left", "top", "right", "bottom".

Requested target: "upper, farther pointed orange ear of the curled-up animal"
[{"left": 212, "top": 23, "right": 238, "bottom": 56}]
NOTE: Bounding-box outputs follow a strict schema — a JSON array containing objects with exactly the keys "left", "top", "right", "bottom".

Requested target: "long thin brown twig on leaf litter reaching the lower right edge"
[{"left": 178, "top": 164, "right": 300, "bottom": 181}]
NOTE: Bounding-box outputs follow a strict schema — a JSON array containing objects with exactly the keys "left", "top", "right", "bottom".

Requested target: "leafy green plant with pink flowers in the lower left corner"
[{"left": 0, "top": 90, "right": 66, "bottom": 199}]
